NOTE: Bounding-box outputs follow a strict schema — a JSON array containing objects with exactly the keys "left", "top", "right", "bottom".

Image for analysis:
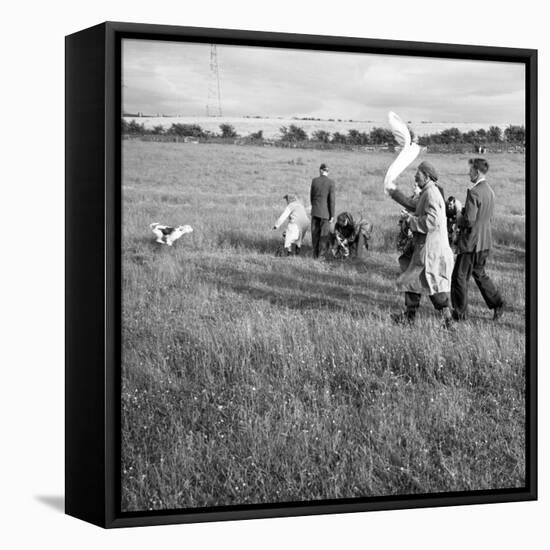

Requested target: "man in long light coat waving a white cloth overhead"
[{"left": 391, "top": 161, "right": 454, "bottom": 325}]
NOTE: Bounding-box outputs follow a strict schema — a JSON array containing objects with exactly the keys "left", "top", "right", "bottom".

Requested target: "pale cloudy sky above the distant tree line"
[{"left": 122, "top": 40, "right": 525, "bottom": 124}]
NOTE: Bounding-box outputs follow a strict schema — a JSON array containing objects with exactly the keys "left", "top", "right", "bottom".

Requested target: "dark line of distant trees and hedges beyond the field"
[{"left": 122, "top": 118, "right": 525, "bottom": 147}]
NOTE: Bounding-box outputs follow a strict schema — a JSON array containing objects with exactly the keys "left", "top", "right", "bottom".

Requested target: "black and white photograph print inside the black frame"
[{"left": 120, "top": 38, "right": 530, "bottom": 513}]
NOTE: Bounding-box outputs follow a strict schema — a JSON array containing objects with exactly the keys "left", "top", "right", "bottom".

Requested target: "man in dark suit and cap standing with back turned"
[{"left": 310, "top": 163, "right": 336, "bottom": 258}]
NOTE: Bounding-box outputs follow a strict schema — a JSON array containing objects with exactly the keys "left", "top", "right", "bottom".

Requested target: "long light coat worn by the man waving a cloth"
[{"left": 397, "top": 181, "right": 454, "bottom": 296}]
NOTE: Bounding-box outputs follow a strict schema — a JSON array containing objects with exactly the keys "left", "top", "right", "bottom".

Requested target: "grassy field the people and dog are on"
[{"left": 122, "top": 141, "right": 525, "bottom": 511}]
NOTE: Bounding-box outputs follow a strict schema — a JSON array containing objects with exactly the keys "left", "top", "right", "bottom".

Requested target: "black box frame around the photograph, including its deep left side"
[{"left": 65, "top": 22, "right": 537, "bottom": 528}]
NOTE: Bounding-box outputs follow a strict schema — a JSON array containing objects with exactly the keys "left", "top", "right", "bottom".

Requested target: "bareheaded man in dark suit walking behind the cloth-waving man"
[{"left": 451, "top": 158, "right": 504, "bottom": 321}]
